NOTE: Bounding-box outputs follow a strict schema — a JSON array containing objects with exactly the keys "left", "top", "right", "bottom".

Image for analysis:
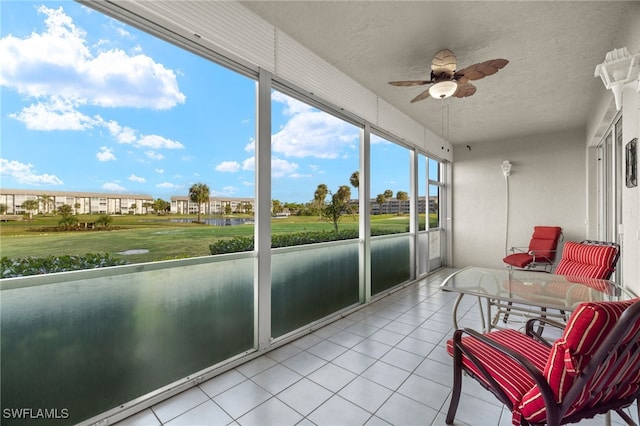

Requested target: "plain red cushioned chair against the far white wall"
[{"left": 502, "top": 226, "right": 562, "bottom": 271}]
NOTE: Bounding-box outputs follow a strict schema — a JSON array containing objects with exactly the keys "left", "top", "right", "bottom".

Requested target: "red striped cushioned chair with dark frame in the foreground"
[{"left": 446, "top": 298, "right": 640, "bottom": 426}]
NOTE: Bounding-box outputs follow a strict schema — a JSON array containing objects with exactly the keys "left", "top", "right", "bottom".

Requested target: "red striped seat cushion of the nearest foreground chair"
[{"left": 447, "top": 329, "right": 551, "bottom": 406}]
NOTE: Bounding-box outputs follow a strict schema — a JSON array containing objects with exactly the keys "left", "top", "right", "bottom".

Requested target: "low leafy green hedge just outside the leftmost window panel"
[{"left": 0, "top": 253, "right": 127, "bottom": 278}]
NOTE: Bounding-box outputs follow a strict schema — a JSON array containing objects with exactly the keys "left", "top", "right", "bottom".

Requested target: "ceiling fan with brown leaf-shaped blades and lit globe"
[{"left": 389, "top": 49, "right": 509, "bottom": 103}]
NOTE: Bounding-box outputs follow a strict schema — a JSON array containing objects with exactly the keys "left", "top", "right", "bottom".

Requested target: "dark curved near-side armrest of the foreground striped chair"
[{"left": 453, "top": 328, "right": 557, "bottom": 413}]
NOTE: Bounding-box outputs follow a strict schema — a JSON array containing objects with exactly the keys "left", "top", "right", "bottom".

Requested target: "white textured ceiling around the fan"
[{"left": 242, "top": 0, "right": 640, "bottom": 144}]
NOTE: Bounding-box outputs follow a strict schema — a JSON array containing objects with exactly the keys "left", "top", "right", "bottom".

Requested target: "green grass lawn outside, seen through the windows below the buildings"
[{"left": 0, "top": 215, "right": 424, "bottom": 263}]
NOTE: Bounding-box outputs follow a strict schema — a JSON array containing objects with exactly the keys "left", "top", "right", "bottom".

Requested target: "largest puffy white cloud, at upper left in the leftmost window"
[{"left": 0, "top": 6, "right": 185, "bottom": 109}]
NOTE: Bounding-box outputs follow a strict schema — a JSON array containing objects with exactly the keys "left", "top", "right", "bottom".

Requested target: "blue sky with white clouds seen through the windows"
[{"left": 0, "top": 0, "right": 436, "bottom": 202}]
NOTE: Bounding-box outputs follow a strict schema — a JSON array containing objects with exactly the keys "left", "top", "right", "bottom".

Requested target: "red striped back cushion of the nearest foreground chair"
[{"left": 517, "top": 299, "right": 640, "bottom": 423}]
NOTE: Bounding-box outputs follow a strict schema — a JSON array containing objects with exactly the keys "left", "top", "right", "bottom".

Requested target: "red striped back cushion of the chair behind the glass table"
[{"left": 554, "top": 241, "right": 617, "bottom": 278}]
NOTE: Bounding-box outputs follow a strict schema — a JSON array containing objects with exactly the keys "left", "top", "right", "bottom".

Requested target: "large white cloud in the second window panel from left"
[{"left": 272, "top": 92, "right": 360, "bottom": 158}]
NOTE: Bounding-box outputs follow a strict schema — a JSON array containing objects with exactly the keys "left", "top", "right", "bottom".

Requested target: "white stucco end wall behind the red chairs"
[{"left": 452, "top": 130, "right": 586, "bottom": 268}]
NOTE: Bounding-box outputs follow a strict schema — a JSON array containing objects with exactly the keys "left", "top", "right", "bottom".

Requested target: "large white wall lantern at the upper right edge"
[{"left": 594, "top": 47, "right": 640, "bottom": 111}]
